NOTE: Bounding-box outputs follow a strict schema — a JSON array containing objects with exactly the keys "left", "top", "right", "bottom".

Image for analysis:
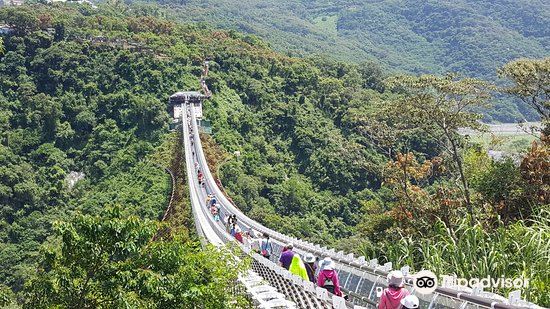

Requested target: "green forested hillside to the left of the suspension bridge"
[{"left": 0, "top": 4, "right": 248, "bottom": 308}]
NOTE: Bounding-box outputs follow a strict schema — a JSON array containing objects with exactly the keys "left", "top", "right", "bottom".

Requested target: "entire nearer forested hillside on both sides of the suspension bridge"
[{"left": 0, "top": 3, "right": 550, "bottom": 308}]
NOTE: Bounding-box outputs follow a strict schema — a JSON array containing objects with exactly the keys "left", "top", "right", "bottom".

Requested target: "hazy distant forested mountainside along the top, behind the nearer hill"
[{"left": 144, "top": 0, "right": 550, "bottom": 122}]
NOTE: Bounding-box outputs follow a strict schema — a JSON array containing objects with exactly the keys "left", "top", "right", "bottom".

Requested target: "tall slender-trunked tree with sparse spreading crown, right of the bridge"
[{"left": 388, "top": 75, "right": 490, "bottom": 216}]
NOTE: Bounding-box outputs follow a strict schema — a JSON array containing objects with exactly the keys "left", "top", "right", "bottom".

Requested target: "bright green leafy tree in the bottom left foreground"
[{"left": 24, "top": 207, "right": 244, "bottom": 308}]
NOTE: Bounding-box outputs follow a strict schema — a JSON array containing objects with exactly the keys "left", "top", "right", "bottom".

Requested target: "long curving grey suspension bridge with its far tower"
[{"left": 171, "top": 60, "right": 536, "bottom": 309}]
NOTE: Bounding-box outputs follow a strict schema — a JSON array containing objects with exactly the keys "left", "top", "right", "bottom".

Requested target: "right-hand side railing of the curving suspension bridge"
[{"left": 185, "top": 100, "right": 536, "bottom": 309}]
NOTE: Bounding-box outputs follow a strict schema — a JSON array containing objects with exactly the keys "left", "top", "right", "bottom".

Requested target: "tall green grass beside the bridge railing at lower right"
[{"left": 379, "top": 207, "right": 550, "bottom": 307}]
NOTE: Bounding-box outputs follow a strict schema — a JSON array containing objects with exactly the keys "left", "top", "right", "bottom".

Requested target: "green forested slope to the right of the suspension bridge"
[{"left": 205, "top": 39, "right": 550, "bottom": 303}]
